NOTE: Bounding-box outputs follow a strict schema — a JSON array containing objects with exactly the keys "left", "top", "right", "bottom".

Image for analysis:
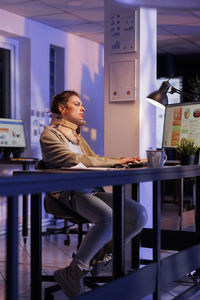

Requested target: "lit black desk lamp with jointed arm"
[{"left": 146, "top": 80, "right": 200, "bottom": 108}]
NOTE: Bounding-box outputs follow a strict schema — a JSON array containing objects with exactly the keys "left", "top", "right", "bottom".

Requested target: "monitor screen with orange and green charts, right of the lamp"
[{"left": 162, "top": 102, "right": 200, "bottom": 148}]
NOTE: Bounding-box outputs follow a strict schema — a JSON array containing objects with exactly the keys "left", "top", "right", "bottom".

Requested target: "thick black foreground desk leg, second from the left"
[{"left": 31, "top": 194, "right": 42, "bottom": 300}]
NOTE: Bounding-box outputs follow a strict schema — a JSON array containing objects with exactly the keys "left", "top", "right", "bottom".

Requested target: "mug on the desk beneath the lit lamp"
[{"left": 146, "top": 150, "right": 167, "bottom": 168}]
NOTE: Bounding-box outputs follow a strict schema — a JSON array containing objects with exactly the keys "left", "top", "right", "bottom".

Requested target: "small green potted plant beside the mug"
[{"left": 176, "top": 138, "right": 199, "bottom": 165}]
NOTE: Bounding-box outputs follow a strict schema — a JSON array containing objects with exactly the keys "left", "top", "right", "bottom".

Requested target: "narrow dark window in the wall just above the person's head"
[{"left": 49, "top": 45, "right": 64, "bottom": 101}]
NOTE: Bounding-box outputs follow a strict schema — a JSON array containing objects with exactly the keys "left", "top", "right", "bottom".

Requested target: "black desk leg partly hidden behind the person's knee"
[{"left": 131, "top": 184, "right": 140, "bottom": 269}]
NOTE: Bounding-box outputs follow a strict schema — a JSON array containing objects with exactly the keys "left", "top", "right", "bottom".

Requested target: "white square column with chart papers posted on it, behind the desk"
[{"left": 104, "top": 0, "right": 157, "bottom": 227}]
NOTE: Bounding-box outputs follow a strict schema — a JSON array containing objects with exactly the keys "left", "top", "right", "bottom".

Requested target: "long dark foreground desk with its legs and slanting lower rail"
[{"left": 5, "top": 165, "right": 200, "bottom": 300}]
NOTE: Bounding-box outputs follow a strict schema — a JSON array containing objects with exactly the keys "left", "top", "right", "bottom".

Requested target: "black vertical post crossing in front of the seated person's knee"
[{"left": 112, "top": 185, "right": 125, "bottom": 279}]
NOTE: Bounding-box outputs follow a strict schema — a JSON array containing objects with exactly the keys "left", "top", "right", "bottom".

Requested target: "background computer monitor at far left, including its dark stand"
[{"left": 0, "top": 118, "right": 26, "bottom": 159}]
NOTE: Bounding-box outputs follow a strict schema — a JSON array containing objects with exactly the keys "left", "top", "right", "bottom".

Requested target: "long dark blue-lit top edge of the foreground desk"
[{"left": 0, "top": 165, "right": 197, "bottom": 195}]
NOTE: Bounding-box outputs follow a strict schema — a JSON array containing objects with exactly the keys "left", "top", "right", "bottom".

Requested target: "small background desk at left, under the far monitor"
[{"left": 0, "top": 157, "right": 38, "bottom": 243}]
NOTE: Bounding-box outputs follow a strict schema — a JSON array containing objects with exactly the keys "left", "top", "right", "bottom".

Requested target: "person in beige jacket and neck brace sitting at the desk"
[{"left": 40, "top": 91, "right": 147, "bottom": 297}]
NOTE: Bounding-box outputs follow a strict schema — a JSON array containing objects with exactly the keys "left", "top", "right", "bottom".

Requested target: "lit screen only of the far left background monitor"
[{"left": 0, "top": 118, "right": 26, "bottom": 149}]
